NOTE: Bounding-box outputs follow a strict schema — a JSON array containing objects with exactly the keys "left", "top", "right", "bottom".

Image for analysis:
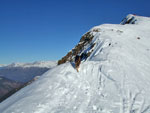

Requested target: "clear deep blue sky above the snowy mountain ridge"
[{"left": 0, "top": 0, "right": 150, "bottom": 64}]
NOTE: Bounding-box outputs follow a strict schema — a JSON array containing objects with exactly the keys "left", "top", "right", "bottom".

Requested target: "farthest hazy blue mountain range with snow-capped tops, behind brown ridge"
[{"left": 0, "top": 61, "right": 57, "bottom": 83}]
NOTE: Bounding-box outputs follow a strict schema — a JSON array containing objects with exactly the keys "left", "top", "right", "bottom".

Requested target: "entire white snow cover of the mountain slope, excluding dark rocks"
[{"left": 0, "top": 15, "right": 150, "bottom": 113}]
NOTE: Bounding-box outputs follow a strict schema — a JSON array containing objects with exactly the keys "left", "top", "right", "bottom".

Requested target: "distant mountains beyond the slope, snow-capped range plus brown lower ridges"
[{"left": 0, "top": 61, "right": 57, "bottom": 102}]
